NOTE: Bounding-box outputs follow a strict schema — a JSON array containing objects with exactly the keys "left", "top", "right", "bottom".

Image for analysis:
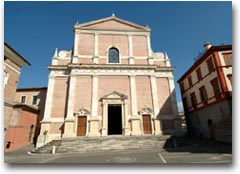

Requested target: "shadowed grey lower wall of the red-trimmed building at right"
[{"left": 187, "top": 100, "right": 232, "bottom": 142}]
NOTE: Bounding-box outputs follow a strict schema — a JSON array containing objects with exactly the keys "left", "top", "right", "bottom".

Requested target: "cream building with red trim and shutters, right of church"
[{"left": 178, "top": 42, "right": 232, "bottom": 142}]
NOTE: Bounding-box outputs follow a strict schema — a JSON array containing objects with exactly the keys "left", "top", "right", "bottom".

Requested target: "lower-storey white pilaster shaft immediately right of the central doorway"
[{"left": 129, "top": 75, "right": 138, "bottom": 116}]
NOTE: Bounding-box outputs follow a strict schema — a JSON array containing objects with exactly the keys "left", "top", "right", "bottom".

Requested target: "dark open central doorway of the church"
[{"left": 108, "top": 105, "right": 122, "bottom": 135}]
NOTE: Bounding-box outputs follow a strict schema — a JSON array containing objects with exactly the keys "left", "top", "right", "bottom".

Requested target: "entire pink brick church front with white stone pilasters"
[{"left": 37, "top": 15, "right": 181, "bottom": 147}]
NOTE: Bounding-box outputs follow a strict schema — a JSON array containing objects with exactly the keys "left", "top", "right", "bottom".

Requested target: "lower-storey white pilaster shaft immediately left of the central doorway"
[{"left": 91, "top": 75, "right": 98, "bottom": 117}]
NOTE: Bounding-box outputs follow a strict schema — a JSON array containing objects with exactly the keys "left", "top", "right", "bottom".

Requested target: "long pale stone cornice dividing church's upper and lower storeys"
[{"left": 48, "top": 64, "right": 174, "bottom": 78}]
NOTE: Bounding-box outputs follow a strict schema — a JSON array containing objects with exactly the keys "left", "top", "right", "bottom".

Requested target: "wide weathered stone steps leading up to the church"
[{"left": 31, "top": 135, "right": 189, "bottom": 153}]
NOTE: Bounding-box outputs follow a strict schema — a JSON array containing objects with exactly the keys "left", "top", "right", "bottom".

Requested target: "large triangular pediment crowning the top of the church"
[{"left": 74, "top": 16, "right": 150, "bottom": 31}]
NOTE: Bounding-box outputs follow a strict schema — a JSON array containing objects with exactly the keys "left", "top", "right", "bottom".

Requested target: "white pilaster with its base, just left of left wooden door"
[{"left": 63, "top": 74, "right": 76, "bottom": 137}]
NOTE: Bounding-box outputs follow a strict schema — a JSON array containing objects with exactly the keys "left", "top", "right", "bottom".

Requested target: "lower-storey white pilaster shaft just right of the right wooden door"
[{"left": 150, "top": 75, "right": 159, "bottom": 117}]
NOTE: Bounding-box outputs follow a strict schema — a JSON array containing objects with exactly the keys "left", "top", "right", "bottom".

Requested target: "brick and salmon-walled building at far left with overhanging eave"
[{"left": 4, "top": 43, "right": 38, "bottom": 152}]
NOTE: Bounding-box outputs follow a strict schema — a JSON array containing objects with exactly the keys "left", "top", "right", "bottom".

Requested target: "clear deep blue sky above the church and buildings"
[{"left": 4, "top": 1, "right": 232, "bottom": 110}]
